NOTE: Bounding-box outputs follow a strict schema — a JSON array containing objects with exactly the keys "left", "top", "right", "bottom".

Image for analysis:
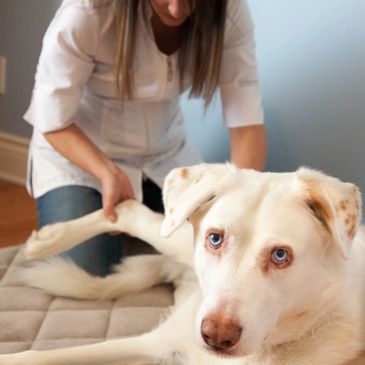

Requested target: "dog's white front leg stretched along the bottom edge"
[{"left": 0, "top": 332, "right": 168, "bottom": 365}]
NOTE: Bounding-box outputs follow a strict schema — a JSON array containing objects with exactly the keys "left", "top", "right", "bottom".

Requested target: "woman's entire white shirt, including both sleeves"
[{"left": 24, "top": 0, "right": 263, "bottom": 199}]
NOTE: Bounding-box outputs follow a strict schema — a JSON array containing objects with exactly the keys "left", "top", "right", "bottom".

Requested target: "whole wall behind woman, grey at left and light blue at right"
[{"left": 0, "top": 0, "right": 365, "bottom": 216}]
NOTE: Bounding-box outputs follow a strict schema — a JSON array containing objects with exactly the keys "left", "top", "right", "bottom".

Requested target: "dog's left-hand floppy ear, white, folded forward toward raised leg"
[{"left": 160, "top": 164, "right": 238, "bottom": 237}]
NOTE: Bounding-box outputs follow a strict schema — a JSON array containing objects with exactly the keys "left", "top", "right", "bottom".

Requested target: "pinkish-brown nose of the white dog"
[{"left": 200, "top": 316, "right": 242, "bottom": 350}]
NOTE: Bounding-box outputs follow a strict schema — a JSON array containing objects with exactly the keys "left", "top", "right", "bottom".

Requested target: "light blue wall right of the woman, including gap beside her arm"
[{"left": 182, "top": 0, "right": 365, "bottom": 218}]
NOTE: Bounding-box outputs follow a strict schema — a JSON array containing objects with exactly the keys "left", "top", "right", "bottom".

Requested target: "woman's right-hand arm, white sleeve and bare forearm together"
[{"left": 220, "top": 0, "right": 266, "bottom": 171}]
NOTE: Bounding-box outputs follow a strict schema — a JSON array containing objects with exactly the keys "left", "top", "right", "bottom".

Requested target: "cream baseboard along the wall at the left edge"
[{"left": 0, "top": 132, "right": 29, "bottom": 186}]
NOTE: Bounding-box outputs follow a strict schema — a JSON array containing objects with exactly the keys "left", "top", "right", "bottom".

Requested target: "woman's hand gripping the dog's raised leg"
[{"left": 100, "top": 161, "right": 134, "bottom": 222}]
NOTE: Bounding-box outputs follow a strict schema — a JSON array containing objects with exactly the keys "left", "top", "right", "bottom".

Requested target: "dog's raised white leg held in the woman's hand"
[{"left": 25, "top": 200, "right": 193, "bottom": 265}]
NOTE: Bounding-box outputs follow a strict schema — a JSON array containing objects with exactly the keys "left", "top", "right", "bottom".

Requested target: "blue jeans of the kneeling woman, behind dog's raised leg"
[{"left": 36, "top": 180, "right": 163, "bottom": 276}]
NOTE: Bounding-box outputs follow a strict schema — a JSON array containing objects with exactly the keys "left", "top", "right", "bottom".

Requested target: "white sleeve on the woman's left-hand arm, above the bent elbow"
[{"left": 24, "top": 0, "right": 99, "bottom": 133}]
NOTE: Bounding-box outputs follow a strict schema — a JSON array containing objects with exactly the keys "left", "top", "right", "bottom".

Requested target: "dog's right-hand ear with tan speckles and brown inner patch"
[{"left": 297, "top": 168, "right": 361, "bottom": 259}]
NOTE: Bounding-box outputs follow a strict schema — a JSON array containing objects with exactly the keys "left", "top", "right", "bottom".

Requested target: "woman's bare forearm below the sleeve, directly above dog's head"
[{"left": 229, "top": 124, "right": 267, "bottom": 171}]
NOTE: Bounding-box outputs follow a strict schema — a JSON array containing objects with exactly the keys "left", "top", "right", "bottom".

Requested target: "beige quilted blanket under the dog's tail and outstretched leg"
[{"left": 0, "top": 246, "right": 173, "bottom": 353}]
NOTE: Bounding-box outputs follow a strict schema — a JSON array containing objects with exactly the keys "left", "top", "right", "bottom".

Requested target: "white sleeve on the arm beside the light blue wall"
[{"left": 219, "top": 0, "right": 264, "bottom": 128}]
